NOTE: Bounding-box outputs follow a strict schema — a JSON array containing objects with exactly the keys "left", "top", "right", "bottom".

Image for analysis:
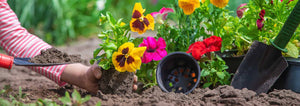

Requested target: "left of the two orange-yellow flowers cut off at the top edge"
[{"left": 178, "top": 0, "right": 200, "bottom": 15}]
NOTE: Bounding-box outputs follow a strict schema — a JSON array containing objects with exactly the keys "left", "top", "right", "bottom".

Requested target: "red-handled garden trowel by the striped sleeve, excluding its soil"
[{"left": 0, "top": 54, "right": 69, "bottom": 69}]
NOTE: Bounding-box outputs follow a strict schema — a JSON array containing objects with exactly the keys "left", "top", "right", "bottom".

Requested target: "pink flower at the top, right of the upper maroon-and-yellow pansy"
[{"left": 150, "top": 7, "right": 174, "bottom": 24}]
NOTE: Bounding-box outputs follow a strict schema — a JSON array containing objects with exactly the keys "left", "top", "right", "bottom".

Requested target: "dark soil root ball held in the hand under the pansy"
[{"left": 98, "top": 69, "right": 134, "bottom": 95}]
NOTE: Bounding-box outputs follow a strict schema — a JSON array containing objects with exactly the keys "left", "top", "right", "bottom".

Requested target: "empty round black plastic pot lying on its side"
[{"left": 156, "top": 52, "right": 200, "bottom": 94}]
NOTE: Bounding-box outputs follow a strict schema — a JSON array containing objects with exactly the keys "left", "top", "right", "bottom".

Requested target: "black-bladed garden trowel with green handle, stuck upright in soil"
[{"left": 231, "top": 1, "right": 300, "bottom": 94}]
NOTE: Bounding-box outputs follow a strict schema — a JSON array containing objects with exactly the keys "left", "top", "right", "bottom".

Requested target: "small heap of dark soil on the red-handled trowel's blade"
[{"left": 29, "top": 48, "right": 82, "bottom": 63}]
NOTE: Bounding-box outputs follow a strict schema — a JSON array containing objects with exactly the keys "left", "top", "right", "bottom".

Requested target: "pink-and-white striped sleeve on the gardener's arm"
[{"left": 0, "top": 0, "right": 66, "bottom": 86}]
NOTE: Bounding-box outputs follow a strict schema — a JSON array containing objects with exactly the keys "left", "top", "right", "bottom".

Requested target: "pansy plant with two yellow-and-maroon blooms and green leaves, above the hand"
[{"left": 90, "top": 3, "right": 154, "bottom": 72}]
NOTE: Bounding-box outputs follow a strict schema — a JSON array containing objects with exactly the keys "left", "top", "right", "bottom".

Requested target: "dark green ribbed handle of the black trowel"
[{"left": 271, "top": 0, "right": 300, "bottom": 52}]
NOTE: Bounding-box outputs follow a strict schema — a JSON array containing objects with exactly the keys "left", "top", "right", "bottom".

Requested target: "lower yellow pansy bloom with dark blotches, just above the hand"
[{"left": 112, "top": 42, "right": 147, "bottom": 72}]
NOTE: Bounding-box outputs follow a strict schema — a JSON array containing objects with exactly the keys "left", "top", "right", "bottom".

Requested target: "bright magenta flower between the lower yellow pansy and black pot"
[{"left": 139, "top": 36, "right": 168, "bottom": 63}]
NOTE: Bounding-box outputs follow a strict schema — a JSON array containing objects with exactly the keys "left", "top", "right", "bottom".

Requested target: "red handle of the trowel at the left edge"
[{"left": 0, "top": 54, "right": 14, "bottom": 69}]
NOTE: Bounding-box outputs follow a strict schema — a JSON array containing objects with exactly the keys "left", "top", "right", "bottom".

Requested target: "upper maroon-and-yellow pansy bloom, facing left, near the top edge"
[{"left": 130, "top": 3, "right": 154, "bottom": 34}]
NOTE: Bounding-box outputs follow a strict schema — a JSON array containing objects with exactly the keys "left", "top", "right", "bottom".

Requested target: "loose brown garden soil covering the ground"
[{"left": 0, "top": 34, "right": 300, "bottom": 106}]
